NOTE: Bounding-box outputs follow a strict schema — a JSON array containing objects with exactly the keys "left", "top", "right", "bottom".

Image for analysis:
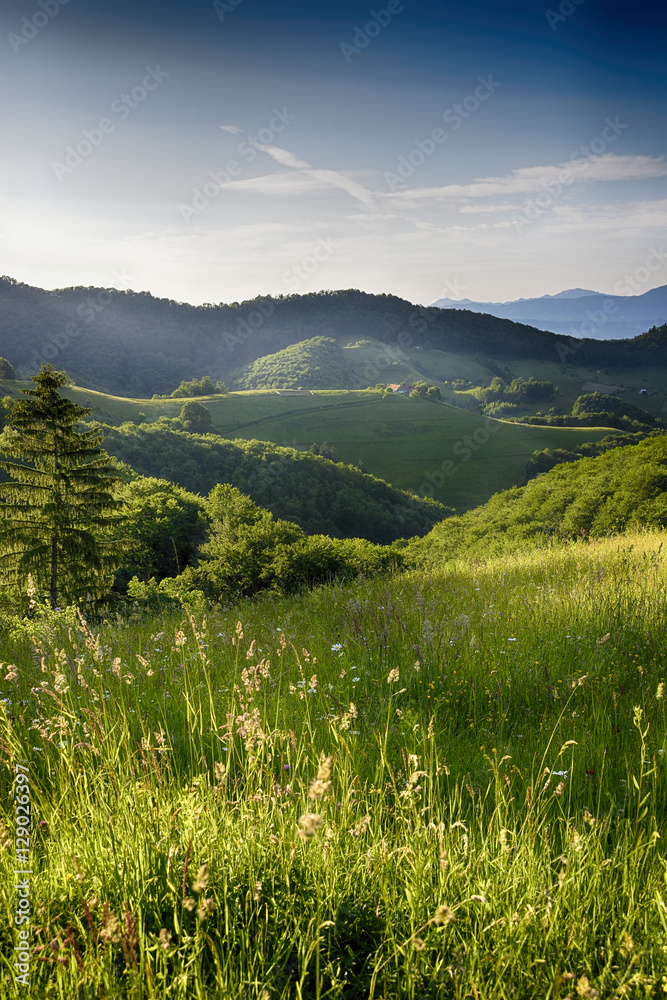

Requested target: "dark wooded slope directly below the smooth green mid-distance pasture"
[{"left": 101, "top": 421, "right": 453, "bottom": 545}]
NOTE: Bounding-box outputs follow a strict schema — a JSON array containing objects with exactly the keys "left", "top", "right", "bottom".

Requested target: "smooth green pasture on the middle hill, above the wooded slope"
[{"left": 52, "top": 380, "right": 628, "bottom": 511}]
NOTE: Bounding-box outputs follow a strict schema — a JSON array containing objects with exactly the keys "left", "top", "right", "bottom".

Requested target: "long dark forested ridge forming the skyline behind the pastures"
[{"left": 0, "top": 277, "right": 667, "bottom": 397}]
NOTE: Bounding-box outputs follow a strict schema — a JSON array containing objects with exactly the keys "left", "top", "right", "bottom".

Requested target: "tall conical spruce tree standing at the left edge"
[{"left": 0, "top": 365, "right": 121, "bottom": 607}]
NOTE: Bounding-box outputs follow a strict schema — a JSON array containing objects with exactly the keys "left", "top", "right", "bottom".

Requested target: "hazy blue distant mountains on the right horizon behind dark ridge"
[{"left": 433, "top": 285, "right": 667, "bottom": 340}]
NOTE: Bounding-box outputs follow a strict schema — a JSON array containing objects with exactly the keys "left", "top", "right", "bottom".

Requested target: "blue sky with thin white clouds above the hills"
[{"left": 0, "top": 0, "right": 667, "bottom": 303}]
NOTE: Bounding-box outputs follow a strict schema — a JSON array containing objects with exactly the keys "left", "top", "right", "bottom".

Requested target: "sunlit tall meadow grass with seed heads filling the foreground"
[{"left": 0, "top": 535, "right": 667, "bottom": 1000}]
